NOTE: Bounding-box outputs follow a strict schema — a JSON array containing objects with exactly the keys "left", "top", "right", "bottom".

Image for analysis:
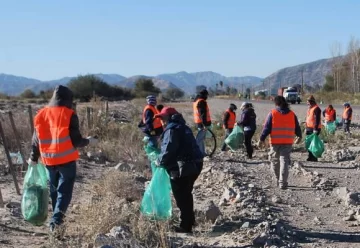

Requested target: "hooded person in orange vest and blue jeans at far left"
[{"left": 28, "top": 85, "right": 97, "bottom": 232}]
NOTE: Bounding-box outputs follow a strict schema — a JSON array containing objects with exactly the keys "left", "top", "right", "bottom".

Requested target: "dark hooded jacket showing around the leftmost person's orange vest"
[{"left": 30, "top": 85, "right": 89, "bottom": 161}]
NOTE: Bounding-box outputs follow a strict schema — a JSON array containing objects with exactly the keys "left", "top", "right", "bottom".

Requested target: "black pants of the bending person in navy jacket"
[{"left": 170, "top": 162, "right": 203, "bottom": 231}]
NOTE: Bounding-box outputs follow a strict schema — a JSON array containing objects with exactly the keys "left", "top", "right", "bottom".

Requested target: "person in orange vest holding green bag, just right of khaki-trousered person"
[{"left": 306, "top": 96, "right": 321, "bottom": 162}]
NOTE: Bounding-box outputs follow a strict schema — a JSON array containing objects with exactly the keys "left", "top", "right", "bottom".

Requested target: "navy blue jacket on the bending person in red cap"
[{"left": 158, "top": 114, "right": 203, "bottom": 177}]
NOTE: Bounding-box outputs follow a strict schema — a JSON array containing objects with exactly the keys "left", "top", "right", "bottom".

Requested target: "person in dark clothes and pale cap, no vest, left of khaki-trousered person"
[{"left": 237, "top": 102, "right": 256, "bottom": 159}]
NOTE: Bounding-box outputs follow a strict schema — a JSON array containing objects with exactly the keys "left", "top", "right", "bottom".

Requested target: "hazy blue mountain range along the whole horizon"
[{"left": 0, "top": 56, "right": 332, "bottom": 95}]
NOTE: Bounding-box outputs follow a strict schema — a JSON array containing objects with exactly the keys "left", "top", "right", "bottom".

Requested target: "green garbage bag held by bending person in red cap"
[{"left": 140, "top": 167, "right": 172, "bottom": 220}]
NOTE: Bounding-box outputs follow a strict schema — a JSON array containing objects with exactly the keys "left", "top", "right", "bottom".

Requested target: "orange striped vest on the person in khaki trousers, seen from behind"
[{"left": 270, "top": 109, "right": 295, "bottom": 145}]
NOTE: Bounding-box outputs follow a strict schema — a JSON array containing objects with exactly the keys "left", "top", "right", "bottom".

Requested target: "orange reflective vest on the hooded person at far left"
[{"left": 34, "top": 107, "right": 79, "bottom": 166}]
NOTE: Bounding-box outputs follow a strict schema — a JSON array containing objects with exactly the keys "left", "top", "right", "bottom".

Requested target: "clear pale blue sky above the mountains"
[{"left": 0, "top": 0, "right": 360, "bottom": 80}]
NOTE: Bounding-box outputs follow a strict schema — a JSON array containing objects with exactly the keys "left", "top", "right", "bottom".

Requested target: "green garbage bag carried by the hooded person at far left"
[{"left": 21, "top": 164, "right": 49, "bottom": 226}]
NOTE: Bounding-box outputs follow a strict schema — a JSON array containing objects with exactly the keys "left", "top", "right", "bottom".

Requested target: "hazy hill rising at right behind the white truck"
[{"left": 264, "top": 58, "right": 333, "bottom": 90}]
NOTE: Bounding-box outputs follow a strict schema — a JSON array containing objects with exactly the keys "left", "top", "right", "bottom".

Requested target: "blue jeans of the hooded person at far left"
[{"left": 46, "top": 161, "right": 76, "bottom": 225}]
